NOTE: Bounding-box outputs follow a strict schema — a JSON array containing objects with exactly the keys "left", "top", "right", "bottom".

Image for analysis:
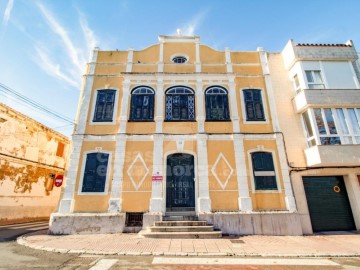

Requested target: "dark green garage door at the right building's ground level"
[{"left": 303, "top": 176, "right": 355, "bottom": 232}]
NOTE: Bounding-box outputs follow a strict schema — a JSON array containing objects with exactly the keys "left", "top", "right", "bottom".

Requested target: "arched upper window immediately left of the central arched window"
[{"left": 130, "top": 86, "right": 155, "bottom": 122}]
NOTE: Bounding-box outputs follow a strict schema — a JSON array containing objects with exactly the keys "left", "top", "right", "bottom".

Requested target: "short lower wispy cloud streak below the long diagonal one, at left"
[{"left": 35, "top": 46, "right": 80, "bottom": 88}]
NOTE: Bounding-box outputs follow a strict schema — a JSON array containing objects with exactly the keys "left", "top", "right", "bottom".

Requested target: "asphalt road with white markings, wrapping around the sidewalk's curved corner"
[{"left": 0, "top": 222, "right": 360, "bottom": 270}]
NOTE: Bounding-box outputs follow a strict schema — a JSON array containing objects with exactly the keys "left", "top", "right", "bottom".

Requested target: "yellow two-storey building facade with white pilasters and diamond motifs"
[{"left": 50, "top": 36, "right": 303, "bottom": 235}]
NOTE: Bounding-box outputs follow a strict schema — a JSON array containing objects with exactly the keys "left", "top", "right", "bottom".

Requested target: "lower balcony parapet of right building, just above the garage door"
[{"left": 305, "top": 144, "right": 360, "bottom": 167}]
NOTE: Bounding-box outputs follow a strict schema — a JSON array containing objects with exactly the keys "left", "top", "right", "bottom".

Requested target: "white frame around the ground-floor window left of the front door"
[{"left": 77, "top": 150, "right": 112, "bottom": 196}]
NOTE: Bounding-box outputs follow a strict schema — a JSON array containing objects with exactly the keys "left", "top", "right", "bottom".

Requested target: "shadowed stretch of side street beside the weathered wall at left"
[{"left": 0, "top": 221, "right": 49, "bottom": 242}]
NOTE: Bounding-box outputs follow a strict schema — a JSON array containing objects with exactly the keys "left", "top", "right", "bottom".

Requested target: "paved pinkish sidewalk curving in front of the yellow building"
[{"left": 17, "top": 231, "right": 360, "bottom": 257}]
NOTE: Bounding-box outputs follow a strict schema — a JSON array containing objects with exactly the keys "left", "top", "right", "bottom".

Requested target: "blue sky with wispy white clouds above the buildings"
[{"left": 0, "top": 0, "right": 360, "bottom": 135}]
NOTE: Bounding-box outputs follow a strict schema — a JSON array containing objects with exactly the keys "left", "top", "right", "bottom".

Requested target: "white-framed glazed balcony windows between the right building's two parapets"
[{"left": 303, "top": 108, "right": 360, "bottom": 146}]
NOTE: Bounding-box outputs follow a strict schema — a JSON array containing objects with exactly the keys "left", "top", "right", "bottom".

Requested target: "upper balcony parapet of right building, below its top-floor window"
[{"left": 293, "top": 89, "right": 360, "bottom": 113}]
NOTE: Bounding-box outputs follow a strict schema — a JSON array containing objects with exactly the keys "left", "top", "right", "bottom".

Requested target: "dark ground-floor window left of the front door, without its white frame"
[{"left": 81, "top": 153, "right": 109, "bottom": 192}]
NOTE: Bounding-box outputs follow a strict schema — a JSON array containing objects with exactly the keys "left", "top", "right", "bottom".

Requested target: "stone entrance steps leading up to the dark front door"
[{"left": 139, "top": 211, "right": 222, "bottom": 239}]
